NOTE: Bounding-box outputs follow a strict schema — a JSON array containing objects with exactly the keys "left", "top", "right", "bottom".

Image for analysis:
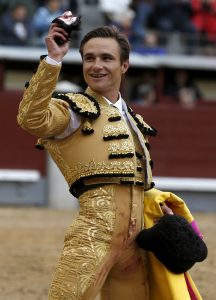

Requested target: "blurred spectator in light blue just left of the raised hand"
[{"left": 33, "top": 0, "right": 64, "bottom": 46}]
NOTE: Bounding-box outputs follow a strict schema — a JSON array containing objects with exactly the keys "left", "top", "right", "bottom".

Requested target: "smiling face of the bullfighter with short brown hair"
[{"left": 83, "top": 38, "right": 129, "bottom": 102}]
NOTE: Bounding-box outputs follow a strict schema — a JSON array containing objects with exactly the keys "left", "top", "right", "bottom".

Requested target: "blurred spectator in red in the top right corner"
[{"left": 191, "top": 0, "right": 216, "bottom": 53}]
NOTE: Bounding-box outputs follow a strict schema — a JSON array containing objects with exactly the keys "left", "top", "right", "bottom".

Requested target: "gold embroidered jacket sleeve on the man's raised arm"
[{"left": 17, "top": 60, "right": 70, "bottom": 138}]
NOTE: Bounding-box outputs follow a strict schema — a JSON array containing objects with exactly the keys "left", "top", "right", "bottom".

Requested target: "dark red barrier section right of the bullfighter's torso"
[{"left": 134, "top": 104, "right": 216, "bottom": 178}]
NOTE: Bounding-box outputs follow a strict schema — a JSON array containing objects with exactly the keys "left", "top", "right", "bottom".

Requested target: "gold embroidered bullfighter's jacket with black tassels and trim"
[{"left": 17, "top": 60, "right": 156, "bottom": 197}]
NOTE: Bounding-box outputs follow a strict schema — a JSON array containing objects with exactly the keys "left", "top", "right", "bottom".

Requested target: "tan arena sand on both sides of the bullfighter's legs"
[{"left": 0, "top": 207, "right": 216, "bottom": 300}]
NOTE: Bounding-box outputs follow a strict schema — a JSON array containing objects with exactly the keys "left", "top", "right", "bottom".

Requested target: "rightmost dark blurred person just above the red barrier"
[{"left": 165, "top": 69, "right": 202, "bottom": 108}]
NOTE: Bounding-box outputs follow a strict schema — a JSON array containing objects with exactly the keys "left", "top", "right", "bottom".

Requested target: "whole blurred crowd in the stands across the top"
[{"left": 0, "top": 0, "right": 216, "bottom": 54}]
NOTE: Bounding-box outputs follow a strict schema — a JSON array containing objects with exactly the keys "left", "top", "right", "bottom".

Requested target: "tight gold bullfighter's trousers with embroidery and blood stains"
[{"left": 49, "top": 184, "right": 149, "bottom": 300}]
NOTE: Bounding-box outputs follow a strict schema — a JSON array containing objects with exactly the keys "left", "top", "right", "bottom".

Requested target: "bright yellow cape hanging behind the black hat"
[{"left": 144, "top": 189, "right": 202, "bottom": 300}]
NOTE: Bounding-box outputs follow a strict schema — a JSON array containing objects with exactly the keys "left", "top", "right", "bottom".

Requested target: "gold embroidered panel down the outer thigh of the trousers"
[{"left": 49, "top": 186, "right": 116, "bottom": 300}]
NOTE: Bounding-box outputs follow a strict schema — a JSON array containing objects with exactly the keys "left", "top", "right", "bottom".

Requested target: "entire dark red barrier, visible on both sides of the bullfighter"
[{"left": 0, "top": 91, "right": 216, "bottom": 178}]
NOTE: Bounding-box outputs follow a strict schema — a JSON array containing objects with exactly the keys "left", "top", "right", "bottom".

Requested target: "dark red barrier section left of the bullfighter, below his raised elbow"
[{"left": 0, "top": 91, "right": 46, "bottom": 175}]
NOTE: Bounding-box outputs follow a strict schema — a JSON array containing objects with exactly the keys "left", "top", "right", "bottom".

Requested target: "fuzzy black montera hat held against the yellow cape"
[{"left": 136, "top": 214, "right": 208, "bottom": 274}]
